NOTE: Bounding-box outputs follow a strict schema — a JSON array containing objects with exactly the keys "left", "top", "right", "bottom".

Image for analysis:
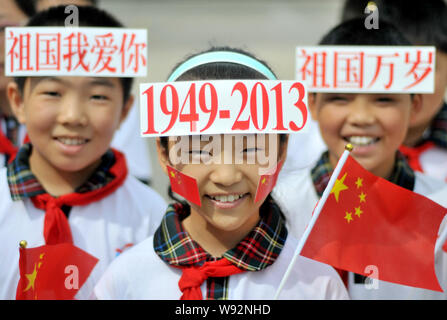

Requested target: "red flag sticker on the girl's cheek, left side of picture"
[{"left": 167, "top": 166, "right": 202, "bottom": 206}]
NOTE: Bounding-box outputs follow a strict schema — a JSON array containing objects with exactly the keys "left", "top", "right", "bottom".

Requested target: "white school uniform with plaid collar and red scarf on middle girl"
[{"left": 95, "top": 201, "right": 348, "bottom": 300}]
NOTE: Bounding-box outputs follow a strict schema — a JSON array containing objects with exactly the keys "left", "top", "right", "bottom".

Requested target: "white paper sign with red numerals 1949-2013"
[{"left": 140, "top": 80, "right": 309, "bottom": 137}]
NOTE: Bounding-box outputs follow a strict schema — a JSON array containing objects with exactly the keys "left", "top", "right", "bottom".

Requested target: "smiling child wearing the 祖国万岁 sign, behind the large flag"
[{"left": 273, "top": 19, "right": 446, "bottom": 299}]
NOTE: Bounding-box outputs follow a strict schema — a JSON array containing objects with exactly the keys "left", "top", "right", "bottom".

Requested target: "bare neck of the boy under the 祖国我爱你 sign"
[{"left": 29, "top": 148, "right": 101, "bottom": 197}]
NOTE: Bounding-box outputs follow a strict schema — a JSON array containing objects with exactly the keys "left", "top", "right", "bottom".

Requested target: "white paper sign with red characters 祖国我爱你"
[{"left": 5, "top": 27, "right": 147, "bottom": 77}]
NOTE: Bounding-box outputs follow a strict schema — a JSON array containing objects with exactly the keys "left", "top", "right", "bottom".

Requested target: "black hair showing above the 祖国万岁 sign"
[{"left": 319, "top": 18, "right": 411, "bottom": 46}]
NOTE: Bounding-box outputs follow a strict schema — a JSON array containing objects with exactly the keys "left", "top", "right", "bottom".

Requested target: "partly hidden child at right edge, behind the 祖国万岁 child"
[{"left": 344, "top": 0, "right": 447, "bottom": 181}]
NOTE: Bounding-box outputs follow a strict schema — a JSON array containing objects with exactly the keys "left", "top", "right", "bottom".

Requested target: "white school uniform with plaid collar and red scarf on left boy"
[{"left": 0, "top": 144, "right": 166, "bottom": 299}]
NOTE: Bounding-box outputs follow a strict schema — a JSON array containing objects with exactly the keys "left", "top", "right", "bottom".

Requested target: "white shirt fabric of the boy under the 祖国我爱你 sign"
[{"left": 0, "top": 168, "right": 167, "bottom": 299}]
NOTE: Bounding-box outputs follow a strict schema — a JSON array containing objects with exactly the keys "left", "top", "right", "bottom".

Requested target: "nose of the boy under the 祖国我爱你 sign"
[{"left": 58, "top": 96, "right": 88, "bottom": 126}]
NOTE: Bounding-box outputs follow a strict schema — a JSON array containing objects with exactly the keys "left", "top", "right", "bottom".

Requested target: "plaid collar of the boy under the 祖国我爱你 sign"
[{"left": 7, "top": 144, "right": 115, "bottom": 201}]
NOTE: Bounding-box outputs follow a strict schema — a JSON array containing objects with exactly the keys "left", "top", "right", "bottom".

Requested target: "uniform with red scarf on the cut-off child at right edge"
[{"left": 400, "top": 103, "right": 447, "bottom": 182}]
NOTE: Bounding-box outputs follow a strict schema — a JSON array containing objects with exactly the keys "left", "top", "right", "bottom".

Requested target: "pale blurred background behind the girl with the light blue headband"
[{"left": 95, "top": 0, "right": 350, "bottom": 199}]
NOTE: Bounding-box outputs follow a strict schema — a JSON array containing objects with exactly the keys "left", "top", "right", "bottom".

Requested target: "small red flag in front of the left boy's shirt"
[{"left": 16, "top": 243, "right": 98, "bottom": 300}]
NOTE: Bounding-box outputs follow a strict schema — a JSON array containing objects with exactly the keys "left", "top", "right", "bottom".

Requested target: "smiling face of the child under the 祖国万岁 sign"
[{"left": 309, "top": 93, "right": 421, "bottom": 178}]
